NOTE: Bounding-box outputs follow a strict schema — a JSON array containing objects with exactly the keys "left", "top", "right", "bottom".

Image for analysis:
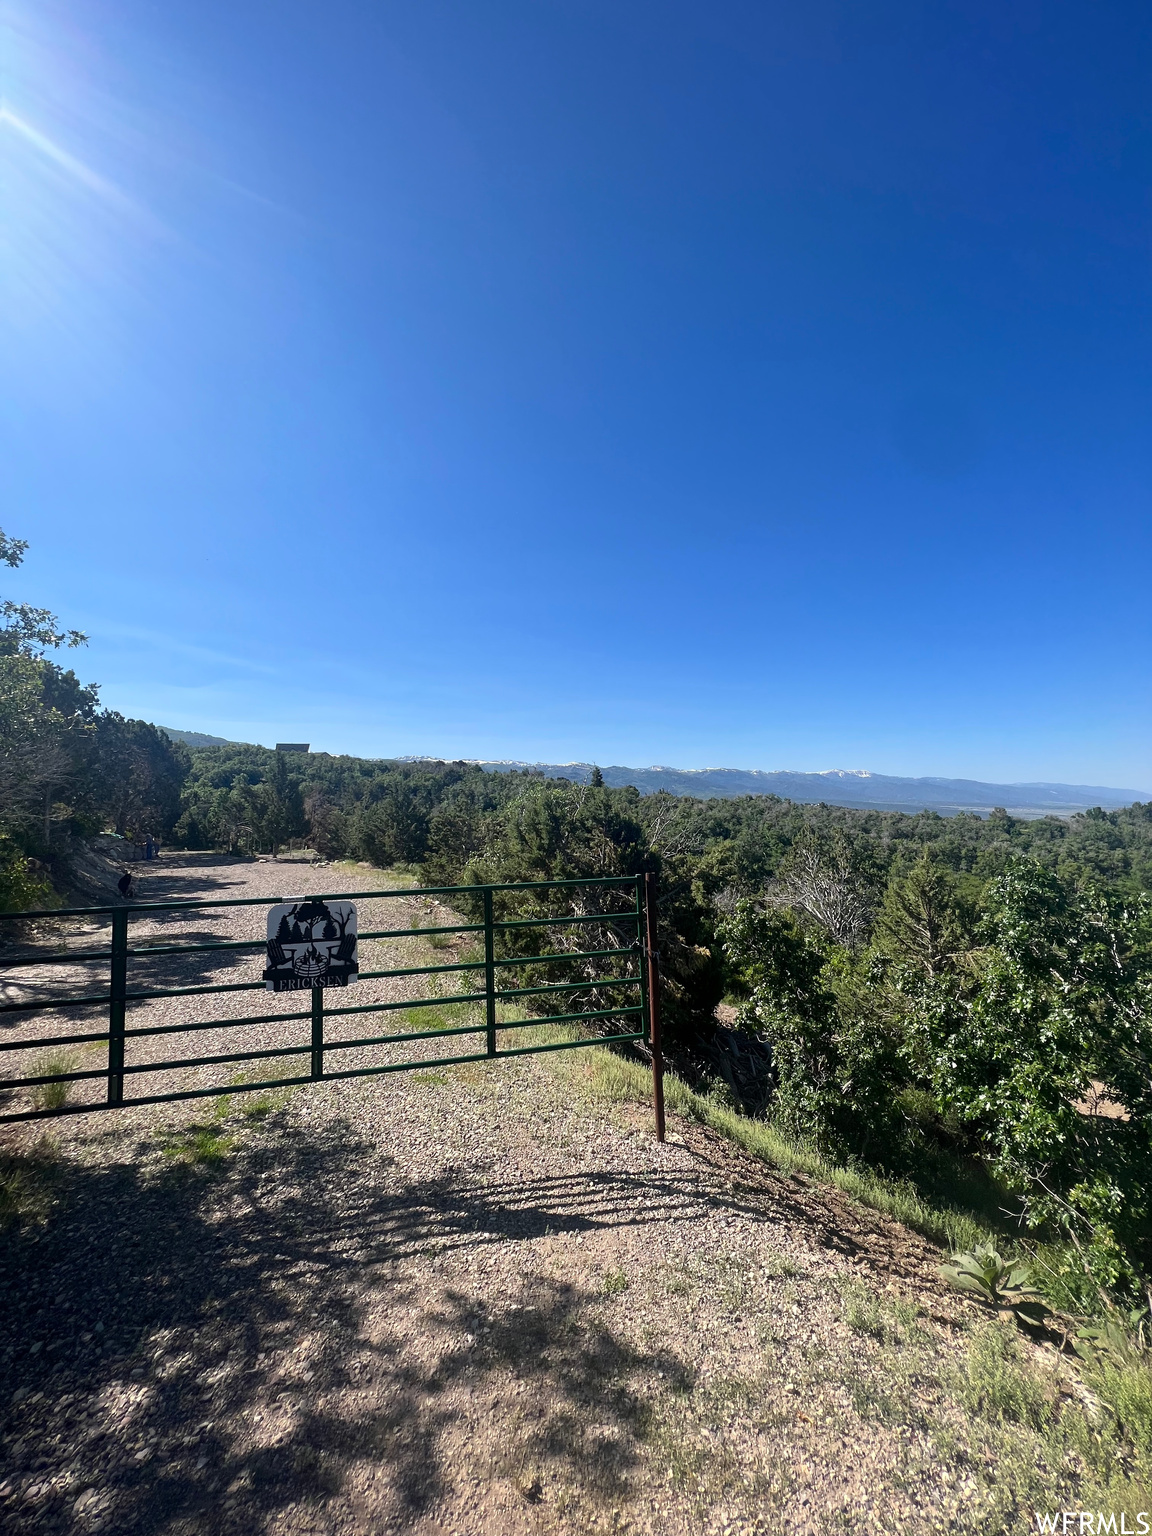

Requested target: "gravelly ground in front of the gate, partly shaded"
[{"left": 0, "top": 859, "right": 1081, "bottom": 1536}]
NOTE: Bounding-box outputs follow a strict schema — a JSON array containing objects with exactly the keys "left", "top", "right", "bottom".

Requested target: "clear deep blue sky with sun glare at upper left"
[{"left": 0, "top": 0, "right": 1152, "bottom": 788}]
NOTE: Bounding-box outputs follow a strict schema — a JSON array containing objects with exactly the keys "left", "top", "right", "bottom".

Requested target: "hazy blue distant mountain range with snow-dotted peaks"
[{"left": 470, "top": 760, "right": 1152, "bottom": 819}]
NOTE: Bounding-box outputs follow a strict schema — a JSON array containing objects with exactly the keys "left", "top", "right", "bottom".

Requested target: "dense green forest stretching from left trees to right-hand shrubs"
[{"left": 0, "top": 535, "right": 1152, "bottom": 1292}]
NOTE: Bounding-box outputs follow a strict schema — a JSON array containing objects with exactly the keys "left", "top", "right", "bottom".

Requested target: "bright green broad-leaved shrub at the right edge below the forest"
[{"left": 908, "top": 859, "right": 1152, "bottom": 1290}]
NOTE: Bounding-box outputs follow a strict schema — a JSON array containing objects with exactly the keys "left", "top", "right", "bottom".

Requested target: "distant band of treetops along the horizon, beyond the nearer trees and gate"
[{"left": 171, "top": 745, "right": 1152, "bottom": 894}]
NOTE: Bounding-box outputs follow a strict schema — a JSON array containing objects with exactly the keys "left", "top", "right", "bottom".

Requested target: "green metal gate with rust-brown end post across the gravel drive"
[{"left": 0, "top": 876, "right": 664, "bottom": 1140}]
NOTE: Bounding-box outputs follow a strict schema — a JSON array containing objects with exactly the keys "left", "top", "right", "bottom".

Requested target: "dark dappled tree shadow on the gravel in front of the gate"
[{"left": 0, "top": 1115, "right": 718, "bottom": 1536}]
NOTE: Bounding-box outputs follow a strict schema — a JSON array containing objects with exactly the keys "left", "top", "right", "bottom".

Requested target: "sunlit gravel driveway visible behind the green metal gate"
[{"left": 0, "top": 854, "right": 497, "bottom": 1123}]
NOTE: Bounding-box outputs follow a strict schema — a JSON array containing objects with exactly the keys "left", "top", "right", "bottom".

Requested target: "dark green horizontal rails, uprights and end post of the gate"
[{"left": 0, "top": 874, "right": 664, "bottom": 1141}]
